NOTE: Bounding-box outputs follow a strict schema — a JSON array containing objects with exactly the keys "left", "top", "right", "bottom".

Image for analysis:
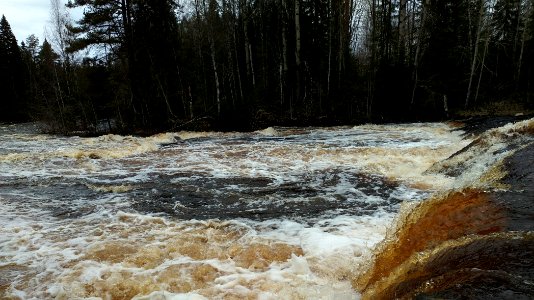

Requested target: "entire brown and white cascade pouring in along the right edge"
[{"left": 352, "top": 120, "right": 534, "bottom": 299}]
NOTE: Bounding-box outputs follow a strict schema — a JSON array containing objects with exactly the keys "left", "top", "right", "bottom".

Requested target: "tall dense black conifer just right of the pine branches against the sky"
[{"left": 130, "top": 0, "right": 183, "bottom": 127}]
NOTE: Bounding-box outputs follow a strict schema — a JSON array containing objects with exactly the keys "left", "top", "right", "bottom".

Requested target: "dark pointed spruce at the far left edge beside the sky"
[{"left": 0, "top": 15, "right": 25, "bottom": 121}]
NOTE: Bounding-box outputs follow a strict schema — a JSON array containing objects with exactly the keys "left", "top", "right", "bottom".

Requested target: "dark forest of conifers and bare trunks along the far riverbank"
[{"left": 0, "top": 0, "right": 534, "bottom": 134}]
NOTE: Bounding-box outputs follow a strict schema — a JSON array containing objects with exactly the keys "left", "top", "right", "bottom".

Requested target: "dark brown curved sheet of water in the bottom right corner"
[{"left": 362, "top": 232, "right": 534, "bottom": 299}]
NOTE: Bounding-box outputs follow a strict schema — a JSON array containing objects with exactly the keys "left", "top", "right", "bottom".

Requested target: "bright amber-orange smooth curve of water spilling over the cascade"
[{"left": 354, "top": 189, "right": 505, "bottom": 290}]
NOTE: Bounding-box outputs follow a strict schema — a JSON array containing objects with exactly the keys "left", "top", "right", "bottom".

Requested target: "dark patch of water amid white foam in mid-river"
[{"left": 132, "top": 173, "right": 414, "bottom": 220}]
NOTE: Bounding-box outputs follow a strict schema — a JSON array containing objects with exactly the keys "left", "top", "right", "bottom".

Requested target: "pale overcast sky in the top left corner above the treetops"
[{"left": 0, "top": 0, "right": 81, "bottom": 44}]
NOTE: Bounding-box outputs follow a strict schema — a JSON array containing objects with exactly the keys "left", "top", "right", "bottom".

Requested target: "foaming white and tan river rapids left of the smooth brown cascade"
[{"left": 0, "top": 123, "right": 532, "bottom": 299}]
